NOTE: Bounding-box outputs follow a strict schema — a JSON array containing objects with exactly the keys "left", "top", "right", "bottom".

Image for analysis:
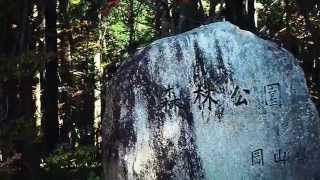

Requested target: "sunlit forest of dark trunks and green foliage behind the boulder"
[{"left": 0, "top": 0, "right": 320, "bottom": 180}]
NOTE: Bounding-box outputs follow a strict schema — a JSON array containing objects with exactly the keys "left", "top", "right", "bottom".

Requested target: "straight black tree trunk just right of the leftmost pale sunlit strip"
[{"left": 42, "top": 0, "right": 59, "bottom": 152}]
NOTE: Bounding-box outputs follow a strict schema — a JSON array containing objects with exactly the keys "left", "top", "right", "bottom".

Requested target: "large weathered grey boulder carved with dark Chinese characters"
[{"left": 103, "top": 22, "right": 320, "bottom": 180}]
